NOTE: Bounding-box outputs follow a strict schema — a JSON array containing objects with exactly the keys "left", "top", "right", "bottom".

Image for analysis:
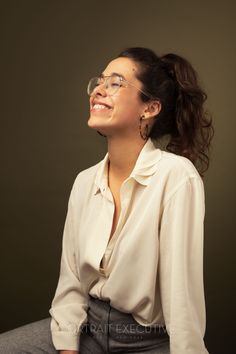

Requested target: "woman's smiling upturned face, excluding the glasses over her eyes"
[{"left": 88, "top": 58, "right": 145, "bottom": 137}]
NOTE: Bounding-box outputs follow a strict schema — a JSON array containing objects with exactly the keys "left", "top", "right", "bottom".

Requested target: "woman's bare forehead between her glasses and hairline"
[{"left": 103, "top": 58, "right": 138, "bottom": 81}]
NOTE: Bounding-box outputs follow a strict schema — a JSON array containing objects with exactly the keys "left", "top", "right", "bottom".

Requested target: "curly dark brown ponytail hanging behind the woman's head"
[{"left": 161, "top": 54, "right": 214, "bottom": 177}]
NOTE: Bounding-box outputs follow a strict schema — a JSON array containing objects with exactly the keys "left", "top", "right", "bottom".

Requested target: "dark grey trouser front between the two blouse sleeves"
[{"left": 80, "top": 295, "right": 169, "bottom": 354}]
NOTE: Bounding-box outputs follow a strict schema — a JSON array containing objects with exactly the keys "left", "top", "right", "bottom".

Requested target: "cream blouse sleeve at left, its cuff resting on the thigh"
[{"left": 49, "top": 177, "right": 88, "bottom": 350}]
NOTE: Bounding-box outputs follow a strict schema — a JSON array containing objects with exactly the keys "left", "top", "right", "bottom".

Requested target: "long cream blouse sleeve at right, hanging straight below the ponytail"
[{"left": 159, "top": 177, "right": 208, "bottom": 354}]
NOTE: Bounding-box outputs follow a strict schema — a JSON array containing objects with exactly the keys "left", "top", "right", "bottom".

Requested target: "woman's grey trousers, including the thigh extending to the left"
[{"left": 0, "top": 297, "right": 170, "bottom": 354}]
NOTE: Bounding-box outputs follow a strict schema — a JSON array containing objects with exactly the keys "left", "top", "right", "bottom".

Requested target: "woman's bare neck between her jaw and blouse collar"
[{"left": 108, "top": 137, "right": 146, "bottom": 179}]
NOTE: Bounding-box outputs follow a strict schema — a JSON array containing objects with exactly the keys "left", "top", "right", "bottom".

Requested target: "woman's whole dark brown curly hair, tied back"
[{"left": 118, "top": 47, "right": 214, "bottom": 177}]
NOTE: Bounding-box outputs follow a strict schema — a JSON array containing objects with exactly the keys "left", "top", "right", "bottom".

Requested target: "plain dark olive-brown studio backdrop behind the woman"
[{"left": 0, "top": 0, "right": 236, "bottom": 354}]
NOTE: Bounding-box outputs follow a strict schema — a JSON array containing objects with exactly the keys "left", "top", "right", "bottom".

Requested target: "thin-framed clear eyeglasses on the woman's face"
[{"left": 87, "top": 75, "right": 153, "bottom": 99}]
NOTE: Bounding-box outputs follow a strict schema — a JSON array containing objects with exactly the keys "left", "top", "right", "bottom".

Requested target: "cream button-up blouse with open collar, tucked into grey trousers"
[{"left": 50, "top": 139, "right": 208, "bottom": 354}]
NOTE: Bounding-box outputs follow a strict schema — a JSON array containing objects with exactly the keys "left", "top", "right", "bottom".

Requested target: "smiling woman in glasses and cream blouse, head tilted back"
[{"left": 0, "top": 48, "right": 213, "bottom": 354}]
